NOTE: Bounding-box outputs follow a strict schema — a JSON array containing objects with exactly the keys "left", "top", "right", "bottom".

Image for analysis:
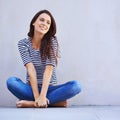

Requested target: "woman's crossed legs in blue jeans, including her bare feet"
[{"left": 7, "top": 77, "right": 81, "bottom": 108}]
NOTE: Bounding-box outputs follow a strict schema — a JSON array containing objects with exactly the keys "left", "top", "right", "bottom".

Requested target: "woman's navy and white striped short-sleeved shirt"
[{"left": 18, "top": 37, "right": 57, "bottom": 84}]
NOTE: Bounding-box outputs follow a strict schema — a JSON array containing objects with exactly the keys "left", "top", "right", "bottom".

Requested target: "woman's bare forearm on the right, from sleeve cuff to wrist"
[{"left": 40, "top": 65, "right": 53, "bottom": 97}]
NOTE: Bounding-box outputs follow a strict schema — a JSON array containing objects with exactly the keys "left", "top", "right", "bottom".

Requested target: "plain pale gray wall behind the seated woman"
[{"left": 0, "top": 0, "right": 120, "bottom": 106}]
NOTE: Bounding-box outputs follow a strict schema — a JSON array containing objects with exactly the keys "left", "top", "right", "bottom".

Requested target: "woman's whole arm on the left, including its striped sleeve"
[{"left": 18, "top": 39, "right": 39, "bottom": 107}]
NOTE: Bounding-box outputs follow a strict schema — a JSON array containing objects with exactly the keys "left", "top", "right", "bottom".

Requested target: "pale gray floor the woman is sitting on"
[{"left": 0, "top": 106, "right": 120, "bottom": 120}]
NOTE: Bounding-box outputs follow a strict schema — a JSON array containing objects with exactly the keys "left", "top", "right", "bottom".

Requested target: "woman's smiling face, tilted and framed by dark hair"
[{"left": 33, "top": 13, "right": 51, "bottom": 35}]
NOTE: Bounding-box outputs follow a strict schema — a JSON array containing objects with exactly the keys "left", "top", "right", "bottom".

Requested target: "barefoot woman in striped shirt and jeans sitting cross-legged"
[{"left": 7, "top": 10, "right": 81, "bottom": 108}]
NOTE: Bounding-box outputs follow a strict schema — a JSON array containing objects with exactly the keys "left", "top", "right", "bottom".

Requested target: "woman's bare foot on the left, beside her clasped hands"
[{"left": 16, "top": 100, "right": 35, "bottom": 108}]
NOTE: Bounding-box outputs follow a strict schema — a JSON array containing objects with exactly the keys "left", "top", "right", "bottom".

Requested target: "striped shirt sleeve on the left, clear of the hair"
[{"left": 18, "top": 40, "right": 32, "bottom": 66}]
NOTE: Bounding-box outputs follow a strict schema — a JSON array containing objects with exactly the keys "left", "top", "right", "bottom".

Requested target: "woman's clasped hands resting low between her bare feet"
[{"left": 35, "top": 96, "right": 49, "bottom": 108}]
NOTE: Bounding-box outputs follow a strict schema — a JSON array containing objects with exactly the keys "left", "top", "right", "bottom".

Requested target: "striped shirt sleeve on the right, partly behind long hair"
[{"left": 46, "top": 38, "right": 58, "bottom": 67}]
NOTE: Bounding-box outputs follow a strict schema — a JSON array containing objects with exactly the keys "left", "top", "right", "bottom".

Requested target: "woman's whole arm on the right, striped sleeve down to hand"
[{"left": 36, "top": 38, "right": 58, "bottom": 107}]
